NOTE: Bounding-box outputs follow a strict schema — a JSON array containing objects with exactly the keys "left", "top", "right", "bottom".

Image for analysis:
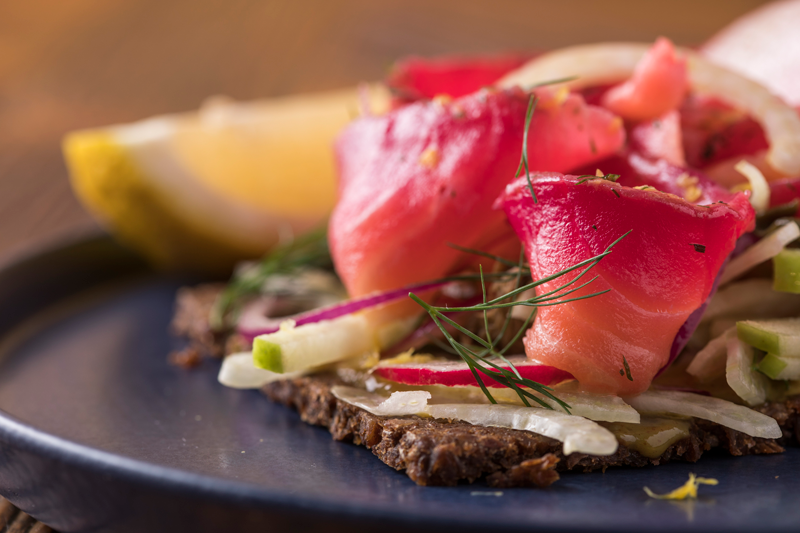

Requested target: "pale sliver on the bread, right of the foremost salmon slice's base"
[{"left": 627, "top": 390, "right": 783, "bottom": 439}]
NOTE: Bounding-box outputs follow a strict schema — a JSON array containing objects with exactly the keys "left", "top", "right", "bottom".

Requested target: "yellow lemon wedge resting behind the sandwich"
[{"left": 63, "top": 87, "right": 388, "bottom": 273}]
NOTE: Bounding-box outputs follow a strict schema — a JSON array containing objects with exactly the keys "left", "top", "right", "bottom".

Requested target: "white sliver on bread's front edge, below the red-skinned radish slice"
[{"left": 426, "top": 404, "right": 619, "bottom": 455}]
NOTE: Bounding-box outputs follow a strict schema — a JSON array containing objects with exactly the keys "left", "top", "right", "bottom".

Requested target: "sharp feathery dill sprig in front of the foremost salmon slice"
[{"left": 408, "top": 231, "right": 630, "bottom": 413}]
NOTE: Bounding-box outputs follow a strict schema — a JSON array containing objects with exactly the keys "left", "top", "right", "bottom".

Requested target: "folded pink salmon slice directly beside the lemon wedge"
[{"left": 329, "top": 89, "right": 625, "bottom": 310}]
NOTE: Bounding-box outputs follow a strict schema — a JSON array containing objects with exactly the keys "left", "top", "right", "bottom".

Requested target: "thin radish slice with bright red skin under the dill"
[{"left": 373, "top": 356, "right": 572, "bottom": 388}]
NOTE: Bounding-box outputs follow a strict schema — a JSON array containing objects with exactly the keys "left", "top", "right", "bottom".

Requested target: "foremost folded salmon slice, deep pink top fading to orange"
[{"left": 498, "top": 173, "right": 754, "bottom": 395}]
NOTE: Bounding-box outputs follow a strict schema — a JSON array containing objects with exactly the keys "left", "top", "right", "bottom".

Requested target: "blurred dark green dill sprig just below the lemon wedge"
[{"left": 209, "top": 226, "right": 333, "bottom": 331}]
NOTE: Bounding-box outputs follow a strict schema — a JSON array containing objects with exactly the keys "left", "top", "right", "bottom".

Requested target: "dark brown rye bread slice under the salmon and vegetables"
[{"left": 262, "top": 374, "right": 800, "bottom": 487}]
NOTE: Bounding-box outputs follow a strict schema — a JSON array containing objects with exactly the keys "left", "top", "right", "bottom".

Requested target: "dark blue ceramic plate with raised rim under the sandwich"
[{"left": 0, "top": 238, "right": 800, "bottom": 533}]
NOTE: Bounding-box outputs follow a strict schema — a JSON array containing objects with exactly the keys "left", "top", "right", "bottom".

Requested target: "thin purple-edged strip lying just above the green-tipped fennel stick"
[{"left": 237, "top": 281, "right": 449, "bottom": 341}]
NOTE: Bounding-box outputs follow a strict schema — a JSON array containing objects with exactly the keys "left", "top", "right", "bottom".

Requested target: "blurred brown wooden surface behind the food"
[{"left": 0, "top": 0, "right": 776, "bottom": 257}]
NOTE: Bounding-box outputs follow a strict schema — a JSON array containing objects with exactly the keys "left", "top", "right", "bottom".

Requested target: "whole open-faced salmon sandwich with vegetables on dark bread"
[{"left": 64, "top": 1, "right": 800, "bottom": 486}]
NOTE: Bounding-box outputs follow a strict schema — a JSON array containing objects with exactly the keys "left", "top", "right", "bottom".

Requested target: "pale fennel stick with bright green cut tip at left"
[{"left": 253, "top": 314, "right": 377, "bottom": 374}]
